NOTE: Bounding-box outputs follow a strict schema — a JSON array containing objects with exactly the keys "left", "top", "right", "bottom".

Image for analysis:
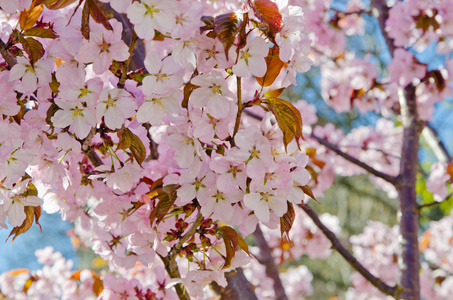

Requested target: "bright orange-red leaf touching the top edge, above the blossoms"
[{"left": 248, "top": 0, "right": 282, "bottom": 34}]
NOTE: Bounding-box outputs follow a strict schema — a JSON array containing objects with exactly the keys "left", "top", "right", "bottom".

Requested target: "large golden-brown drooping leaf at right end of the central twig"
[{"left": 264, "top": 97, "right": 303, "bottom": 149}]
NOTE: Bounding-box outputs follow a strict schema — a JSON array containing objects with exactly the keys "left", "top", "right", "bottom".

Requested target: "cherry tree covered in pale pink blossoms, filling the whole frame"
[{"left": 0, "top": 0, "right": 453, "bottom": 299}]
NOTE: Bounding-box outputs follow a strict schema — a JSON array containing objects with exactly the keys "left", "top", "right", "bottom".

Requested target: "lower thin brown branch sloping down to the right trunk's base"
[{"left": 299, "top": 204, "right": 400, "bottom": 299}]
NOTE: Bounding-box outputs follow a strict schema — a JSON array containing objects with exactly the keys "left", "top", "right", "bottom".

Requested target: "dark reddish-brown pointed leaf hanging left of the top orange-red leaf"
[{"left": 214, "top": 13, "right": 239, "bottom": 60}]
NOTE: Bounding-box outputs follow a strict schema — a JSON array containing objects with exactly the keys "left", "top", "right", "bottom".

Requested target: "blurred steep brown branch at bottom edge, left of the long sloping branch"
[{"left": 253, "top": 224, "right": 288, "bottom": 300}]
